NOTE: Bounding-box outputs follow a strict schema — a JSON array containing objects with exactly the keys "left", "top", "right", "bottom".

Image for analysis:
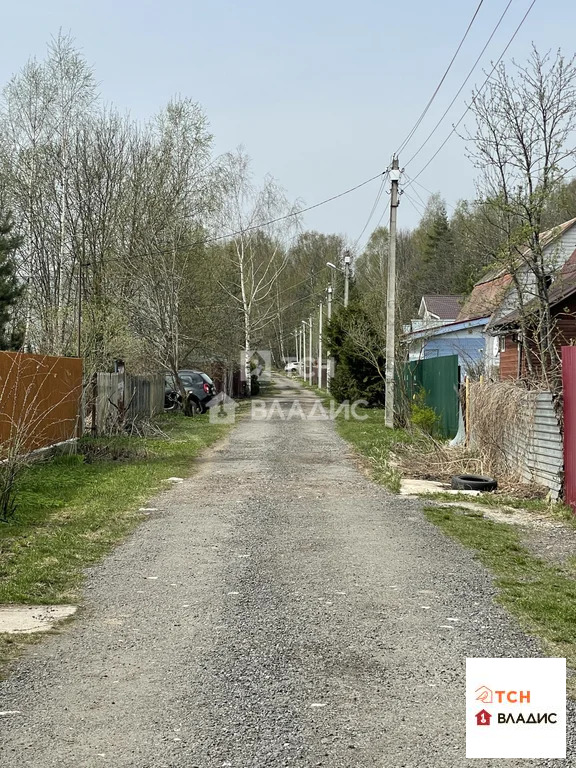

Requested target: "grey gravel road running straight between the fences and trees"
[{"left": 0, "top": 379, "right": 576, "bottom": 768}]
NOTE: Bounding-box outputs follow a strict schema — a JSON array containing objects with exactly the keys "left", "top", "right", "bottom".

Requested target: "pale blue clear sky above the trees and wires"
[{"left": 0, "top": 0, "right": 576, "bottom": 248}]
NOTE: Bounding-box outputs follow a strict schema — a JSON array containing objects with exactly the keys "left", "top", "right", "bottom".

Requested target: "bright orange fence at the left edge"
[{"left": 0, "top": 352, "right": 82, "bottom": 455}]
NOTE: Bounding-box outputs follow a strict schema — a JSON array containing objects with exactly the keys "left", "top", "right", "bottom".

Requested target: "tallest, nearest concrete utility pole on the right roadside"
[{"left": 385, "top": 156, "right": 400, "bottom": 428}]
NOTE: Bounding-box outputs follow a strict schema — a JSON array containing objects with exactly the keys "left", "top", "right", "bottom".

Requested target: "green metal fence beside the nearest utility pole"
[{"left": 404, "top": 355, "right": 459, "bottom": 438}]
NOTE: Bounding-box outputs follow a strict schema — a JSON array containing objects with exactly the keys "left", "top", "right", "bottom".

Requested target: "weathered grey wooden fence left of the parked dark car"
[{"left": 89, "top": 373, "right": 164, "bottom": 434}]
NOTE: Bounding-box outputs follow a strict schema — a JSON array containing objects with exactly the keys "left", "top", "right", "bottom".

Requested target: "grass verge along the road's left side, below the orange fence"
[{"left": 0, "top": 414, "right": 234, "bottom": 662}]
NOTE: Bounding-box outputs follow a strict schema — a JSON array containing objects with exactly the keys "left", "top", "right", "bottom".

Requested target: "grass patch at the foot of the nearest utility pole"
[{"left": 336, "top": 408, "right": 412, "bottom": 493}]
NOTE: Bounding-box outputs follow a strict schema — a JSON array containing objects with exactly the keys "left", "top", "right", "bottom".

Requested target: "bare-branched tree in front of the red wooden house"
[{"left": 467, "top": 48, "right": 576, "bottom": 391}]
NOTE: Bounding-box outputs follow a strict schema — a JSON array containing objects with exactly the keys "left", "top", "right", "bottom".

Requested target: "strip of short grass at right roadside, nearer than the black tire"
[{"left": 425, "top": 507, "right": 576, "bottom": 680}]
